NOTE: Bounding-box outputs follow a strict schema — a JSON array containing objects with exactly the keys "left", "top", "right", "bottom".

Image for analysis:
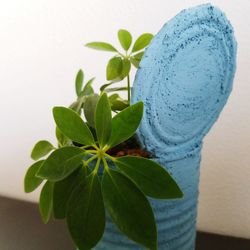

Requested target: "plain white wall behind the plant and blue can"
[{"left": 0, "top": 0, "right": 250, "bottom": 238}]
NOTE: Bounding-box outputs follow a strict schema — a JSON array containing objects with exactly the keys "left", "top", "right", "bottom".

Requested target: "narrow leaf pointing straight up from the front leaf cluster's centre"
[{"left": 95, "top": 93, "right": 112, "bottom": 147}]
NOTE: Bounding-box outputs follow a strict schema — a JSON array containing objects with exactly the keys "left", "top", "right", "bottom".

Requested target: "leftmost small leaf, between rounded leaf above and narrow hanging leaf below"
[{"left": 24, "top": 160, "right": 44, "bottom": 193}]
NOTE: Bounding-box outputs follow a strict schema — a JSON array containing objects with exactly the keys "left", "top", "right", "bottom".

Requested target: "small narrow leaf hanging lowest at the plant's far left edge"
[{"left": 39, "top": 181, "right": 54, "bottom": 224}]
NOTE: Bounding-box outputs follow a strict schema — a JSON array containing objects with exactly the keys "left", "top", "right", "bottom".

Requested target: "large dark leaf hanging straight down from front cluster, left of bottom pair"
[{"left": 67, "top": 173, "right": 105, "bottom": 250}]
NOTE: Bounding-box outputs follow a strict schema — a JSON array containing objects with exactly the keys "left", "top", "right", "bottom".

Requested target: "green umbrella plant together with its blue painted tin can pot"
[{"left": 25, "top": 4, "right": 237, "bottom": 250}]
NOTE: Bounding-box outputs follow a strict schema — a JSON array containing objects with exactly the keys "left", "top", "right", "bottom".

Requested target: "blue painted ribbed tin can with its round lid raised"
[{"left": 95, "top": 4, "right": 236, "bottom": 250}]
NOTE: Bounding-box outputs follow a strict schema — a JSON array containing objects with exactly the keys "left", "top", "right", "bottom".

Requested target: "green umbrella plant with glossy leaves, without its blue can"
[{"left": 24, "top": 30, "right": 183, "bottom": 250}]
